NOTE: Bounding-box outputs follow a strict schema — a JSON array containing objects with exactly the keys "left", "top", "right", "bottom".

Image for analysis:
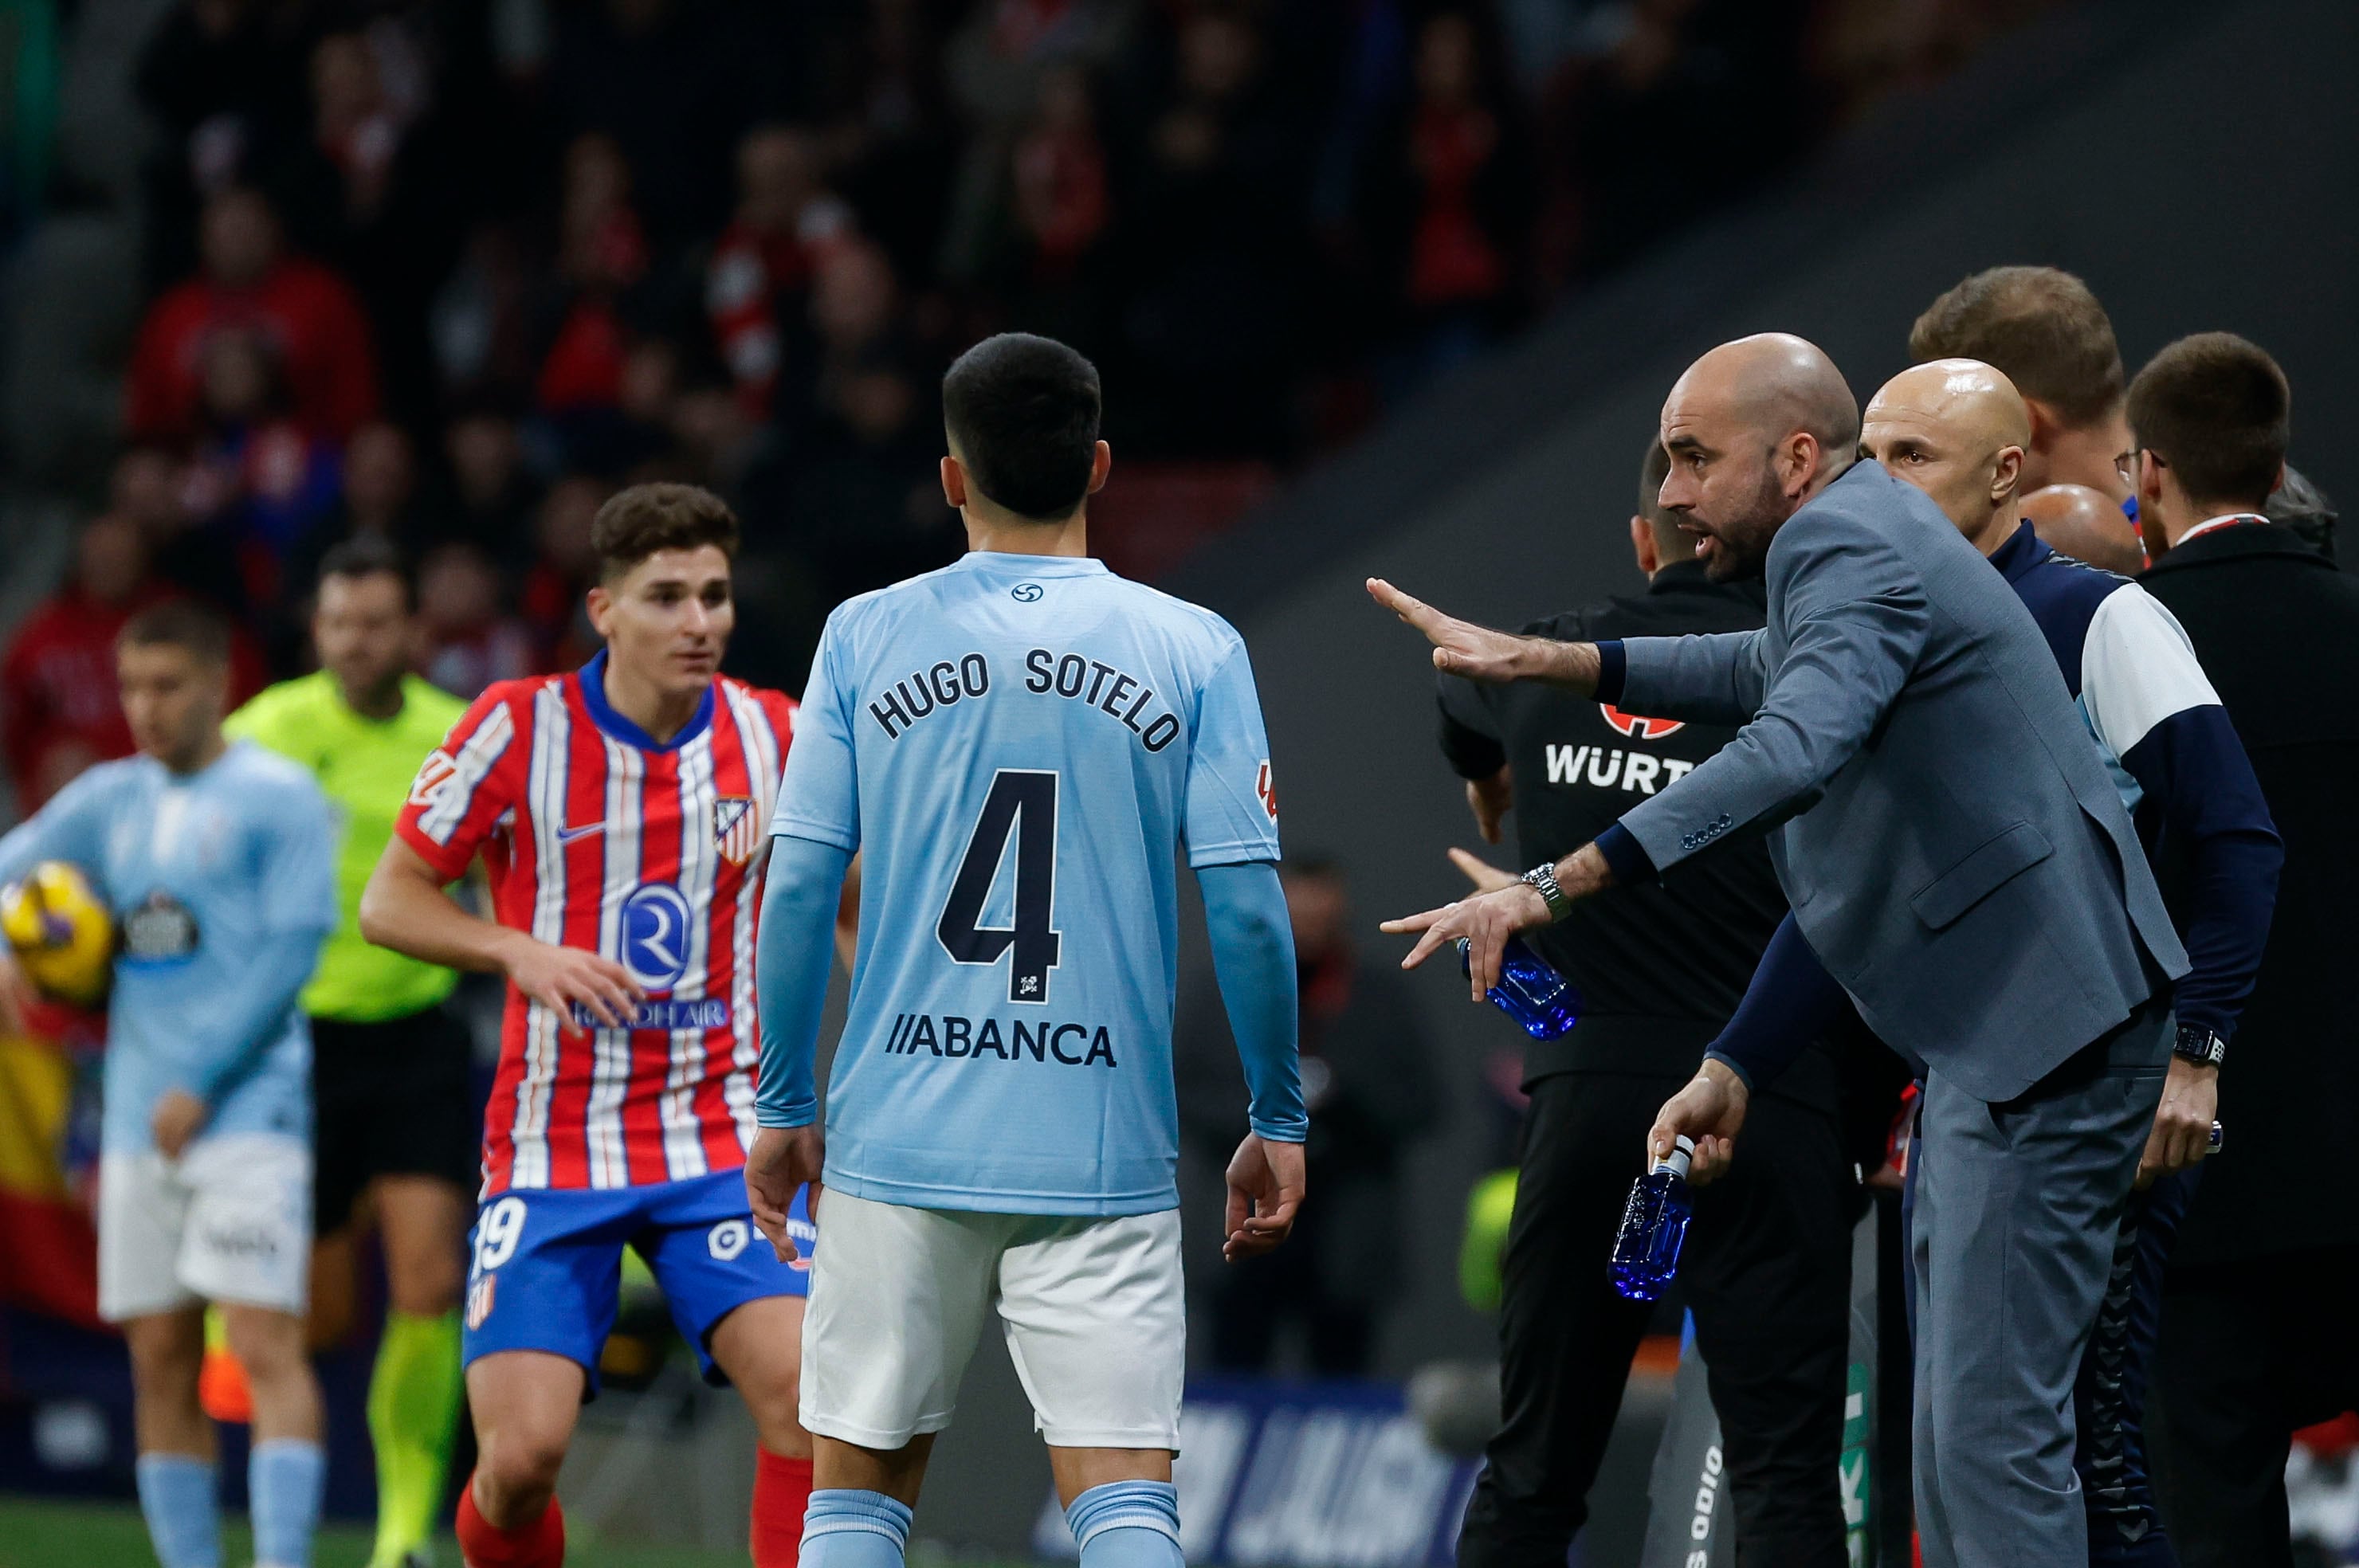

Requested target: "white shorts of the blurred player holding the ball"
[{"left": 99, "top": 1132, "right": 312, "bottom": 1323}]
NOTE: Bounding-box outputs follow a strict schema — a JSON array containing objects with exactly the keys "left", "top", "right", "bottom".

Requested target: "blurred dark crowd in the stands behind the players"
[{"left": 0, "top": 0, "right": 2043, "bottom": 804}]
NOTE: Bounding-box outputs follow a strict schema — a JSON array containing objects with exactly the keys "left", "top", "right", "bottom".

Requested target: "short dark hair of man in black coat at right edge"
[{"left": 2130, "top": 332, "right": 2293, "bottom": 509}]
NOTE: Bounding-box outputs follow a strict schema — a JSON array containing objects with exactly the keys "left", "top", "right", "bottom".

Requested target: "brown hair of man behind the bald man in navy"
[{"left": 1909, "top": 266, "right": 2121, "bottom": 427}]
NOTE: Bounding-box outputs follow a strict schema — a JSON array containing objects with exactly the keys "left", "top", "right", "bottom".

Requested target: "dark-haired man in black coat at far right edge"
[{"left": 2125, "top": 332, "right": 2359, "bottom": 1568}]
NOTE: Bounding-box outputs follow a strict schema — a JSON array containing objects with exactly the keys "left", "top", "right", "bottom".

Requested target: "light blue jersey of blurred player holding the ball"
[{"left": 0, "top": 740, "right": 337, "bottom": 1153}]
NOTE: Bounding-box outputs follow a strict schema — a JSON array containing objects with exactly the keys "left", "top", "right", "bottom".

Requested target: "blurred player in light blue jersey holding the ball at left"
[{"left": 0, "top": 604, "right": 335, "bottom": 1568}]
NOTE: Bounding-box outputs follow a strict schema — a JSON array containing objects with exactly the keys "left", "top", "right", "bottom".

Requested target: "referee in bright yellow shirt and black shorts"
[{"left": 222, "top": 538, "right": 479, "bottom": 1568}]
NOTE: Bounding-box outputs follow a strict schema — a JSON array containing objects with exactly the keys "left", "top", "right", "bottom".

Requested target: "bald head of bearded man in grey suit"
[{"left": 1661, "top": 332, "right": 1859, "bottom": 582}]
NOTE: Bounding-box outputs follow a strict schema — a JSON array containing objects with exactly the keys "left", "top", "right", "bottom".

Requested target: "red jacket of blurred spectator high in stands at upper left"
[{"left": 130, "top": 260, "right": 378, "bottom": 443}]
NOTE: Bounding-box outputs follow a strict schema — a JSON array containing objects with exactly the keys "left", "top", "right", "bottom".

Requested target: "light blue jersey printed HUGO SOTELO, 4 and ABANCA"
[{"left": 774, "top": 551, "right": 1278, "bottom": 1214}]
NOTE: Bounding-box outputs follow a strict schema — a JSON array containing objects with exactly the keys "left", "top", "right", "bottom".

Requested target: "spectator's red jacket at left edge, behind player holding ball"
[{"left": 0, "top": 582, "right": 265, "bottom": 811}]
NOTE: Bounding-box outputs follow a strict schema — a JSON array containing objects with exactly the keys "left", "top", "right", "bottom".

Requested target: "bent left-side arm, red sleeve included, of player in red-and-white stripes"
[{"left": 361, "top": 684, "right": 644, "bottom": 1028}]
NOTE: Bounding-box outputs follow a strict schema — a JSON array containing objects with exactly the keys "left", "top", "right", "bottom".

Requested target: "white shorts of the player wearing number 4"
[{"left": 802, "top": 1189, "right": 1187, "bottom": 1452}]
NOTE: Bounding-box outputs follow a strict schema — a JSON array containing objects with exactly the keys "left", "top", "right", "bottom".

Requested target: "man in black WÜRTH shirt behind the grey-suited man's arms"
[{"left": 1442, "top": 445, "right": 1861, "bottom": 1568}]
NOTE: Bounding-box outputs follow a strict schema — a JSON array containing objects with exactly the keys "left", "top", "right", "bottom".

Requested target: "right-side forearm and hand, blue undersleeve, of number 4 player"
[{"left": 1196, "top": 860, "right": 1309, "bottom": 1259}]
